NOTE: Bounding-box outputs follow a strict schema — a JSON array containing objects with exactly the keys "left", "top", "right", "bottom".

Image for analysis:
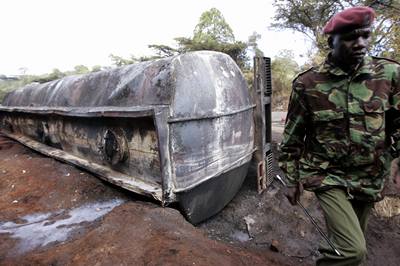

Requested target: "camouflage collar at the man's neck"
[{"left": 318, "top": 54, "right": 373, "bottom": 77}]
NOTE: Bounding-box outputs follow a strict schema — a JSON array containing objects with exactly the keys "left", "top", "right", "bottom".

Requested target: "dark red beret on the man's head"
[{"left": 324, "top": 6, "right": 376, "bottom": 34}]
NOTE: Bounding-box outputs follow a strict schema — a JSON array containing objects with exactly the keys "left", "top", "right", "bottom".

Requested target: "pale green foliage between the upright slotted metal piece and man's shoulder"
[{"left": 271, "top": 50, "right": 300, "bottom": 110}]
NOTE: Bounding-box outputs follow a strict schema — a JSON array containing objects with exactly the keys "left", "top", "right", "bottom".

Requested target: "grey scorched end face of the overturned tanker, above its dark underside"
[{"left": 170, "top": 54, "right": 254, "bottom": 192}]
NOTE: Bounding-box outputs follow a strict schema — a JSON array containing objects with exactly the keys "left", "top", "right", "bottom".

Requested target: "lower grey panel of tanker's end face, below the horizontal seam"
[{"left": 171, "top": 110, "right": 254, "bottom": 192}]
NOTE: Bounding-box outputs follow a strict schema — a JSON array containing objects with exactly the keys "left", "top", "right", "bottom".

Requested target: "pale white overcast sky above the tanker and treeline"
[{"left": 0, "top": 0, "right": 309, "bottom": 75}]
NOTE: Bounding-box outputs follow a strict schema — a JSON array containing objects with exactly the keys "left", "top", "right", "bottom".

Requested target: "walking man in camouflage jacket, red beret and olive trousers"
[{"left": 279, "top": 7, "right": 400, "bottom": 265}]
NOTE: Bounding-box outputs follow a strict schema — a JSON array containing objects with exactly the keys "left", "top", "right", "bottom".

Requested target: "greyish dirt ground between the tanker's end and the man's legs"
[{"left": 200, "top": 125, "right": 400, "bottom": 266}]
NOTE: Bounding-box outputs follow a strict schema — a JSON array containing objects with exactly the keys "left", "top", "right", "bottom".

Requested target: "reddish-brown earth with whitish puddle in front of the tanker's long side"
[{"left": 0, "top": 137, "right": 291, "bottom": 265}]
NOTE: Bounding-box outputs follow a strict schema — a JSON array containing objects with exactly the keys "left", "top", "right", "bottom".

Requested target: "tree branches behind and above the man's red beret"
[{"left": 271, "top": 0, "right": 400, "bottom": 61}]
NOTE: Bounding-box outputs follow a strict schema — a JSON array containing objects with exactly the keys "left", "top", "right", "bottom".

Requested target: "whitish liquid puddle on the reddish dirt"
[{"left": 0, "top": 199, "right": 124, "bottom": 253}]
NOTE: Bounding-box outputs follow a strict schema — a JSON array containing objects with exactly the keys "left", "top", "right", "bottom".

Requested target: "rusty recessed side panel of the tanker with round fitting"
[{"left": 2, "top": 111, "right": 162, "bottom": 190}]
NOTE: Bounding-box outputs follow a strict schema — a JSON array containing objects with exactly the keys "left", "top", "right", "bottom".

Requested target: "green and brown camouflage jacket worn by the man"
[{"left": 279, "top": 57, "right": 400, "bottom": 201}]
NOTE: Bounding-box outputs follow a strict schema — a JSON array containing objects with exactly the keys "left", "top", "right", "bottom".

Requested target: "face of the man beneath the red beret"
[{"left": 332, "top": 27, "right": 371, "bottom": 65}]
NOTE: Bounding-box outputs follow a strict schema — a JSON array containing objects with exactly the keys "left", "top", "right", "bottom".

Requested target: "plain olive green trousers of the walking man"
[{"left": 315, "top": 188, "right": 374, "bottom": 266}]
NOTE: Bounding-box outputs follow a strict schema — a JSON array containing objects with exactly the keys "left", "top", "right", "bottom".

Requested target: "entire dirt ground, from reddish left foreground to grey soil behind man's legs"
[{"left": 0, "top": 128, "right": 400, "bottom": 265}]
